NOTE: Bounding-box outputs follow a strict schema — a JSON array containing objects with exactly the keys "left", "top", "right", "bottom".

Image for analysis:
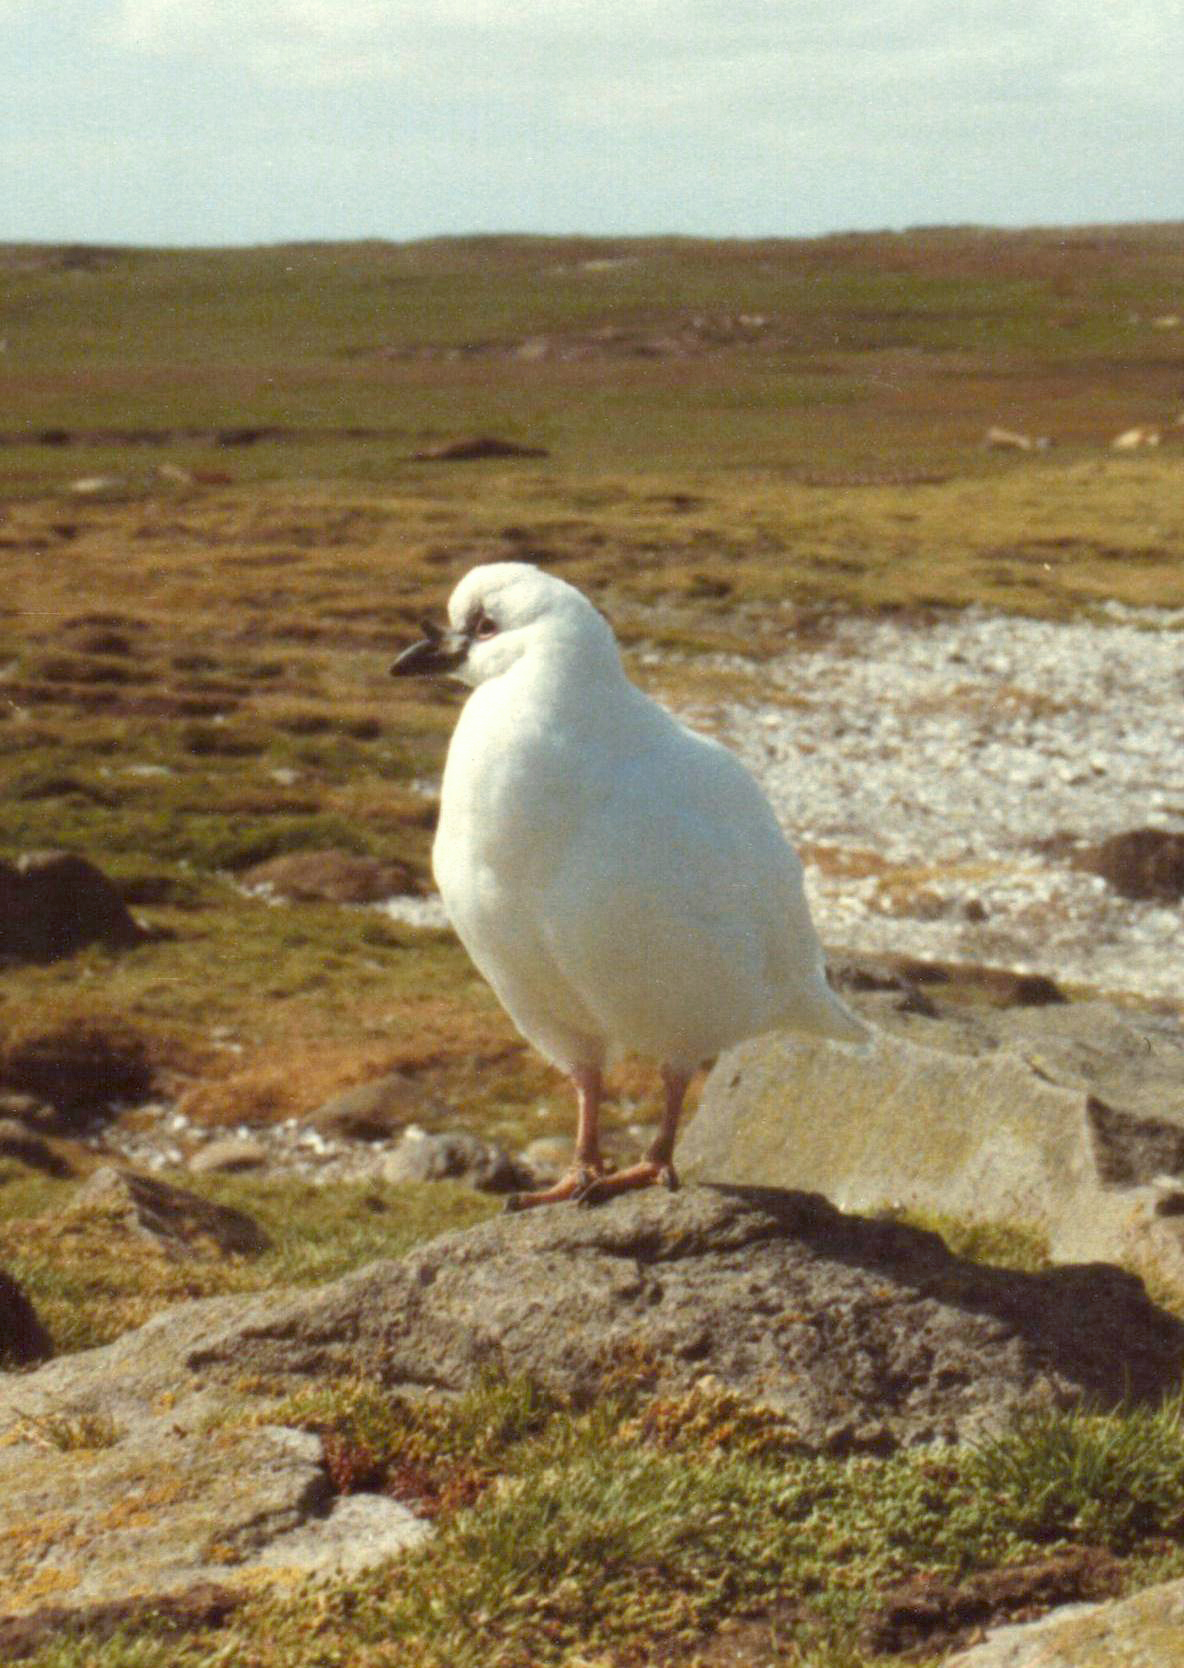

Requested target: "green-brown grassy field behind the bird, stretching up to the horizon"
[{"left": 0, "top": 225, "right": 1184, "bottom": 1126}]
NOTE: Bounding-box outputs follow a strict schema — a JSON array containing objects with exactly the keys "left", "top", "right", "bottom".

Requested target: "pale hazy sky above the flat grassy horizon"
[{"left": 0, "top": 0, "right": 1184, "bottom": 245}]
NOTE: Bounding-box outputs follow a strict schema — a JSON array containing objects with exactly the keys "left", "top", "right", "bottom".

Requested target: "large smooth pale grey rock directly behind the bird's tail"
[{"left": 679, "top": 989, "right": 1184, "bottom": 1284}]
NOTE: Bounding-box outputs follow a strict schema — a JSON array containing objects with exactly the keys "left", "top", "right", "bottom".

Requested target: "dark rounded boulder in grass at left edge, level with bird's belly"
[{"left": 0, "top": 851, "right": 147, "bottom": 961}]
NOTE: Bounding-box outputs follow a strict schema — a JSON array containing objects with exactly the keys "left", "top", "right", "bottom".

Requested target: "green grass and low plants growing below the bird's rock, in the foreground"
[{"left": 16, "top": 1379, "right": 1184, "bottom": 1668}]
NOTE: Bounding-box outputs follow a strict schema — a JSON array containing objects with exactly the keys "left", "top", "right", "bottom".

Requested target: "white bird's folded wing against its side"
[{"left": 540, "top": 731, "right": 840, "bottom": 1064}]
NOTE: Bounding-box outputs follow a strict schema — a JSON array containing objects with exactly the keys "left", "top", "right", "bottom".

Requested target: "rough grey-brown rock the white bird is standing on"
[{"left": 0, "top": 1188, "right": 1184, "bottom": 1448}]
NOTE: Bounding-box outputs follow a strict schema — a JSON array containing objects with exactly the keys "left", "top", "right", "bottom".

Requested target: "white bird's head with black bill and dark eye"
[{"left": 390, "top": 562, "right": 619, "bottom": 687}]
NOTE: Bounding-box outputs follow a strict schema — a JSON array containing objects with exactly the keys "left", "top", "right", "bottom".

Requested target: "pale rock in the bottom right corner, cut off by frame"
[{"left": 946, "top": 1581, "right": 1184, "bottom": 1668}]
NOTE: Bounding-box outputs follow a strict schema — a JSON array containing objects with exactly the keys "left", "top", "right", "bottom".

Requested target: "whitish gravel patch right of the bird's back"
[{"left": 712, "top": 609, "right": 1184, "bottom": 999}]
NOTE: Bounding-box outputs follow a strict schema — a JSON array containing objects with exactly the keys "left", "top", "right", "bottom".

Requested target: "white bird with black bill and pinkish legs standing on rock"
[{"left": 392, "top": 562, "right": 865, "bottom": 1208}]
